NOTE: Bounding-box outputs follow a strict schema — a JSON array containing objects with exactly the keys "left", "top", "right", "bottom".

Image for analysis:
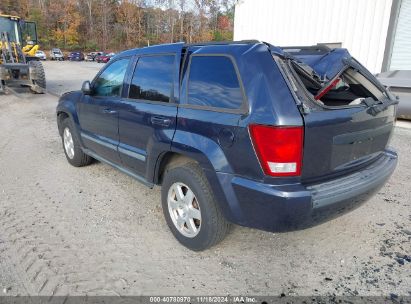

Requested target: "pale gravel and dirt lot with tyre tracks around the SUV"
[{"left": 0, "top": 62, "right": 411, "bottom": 296}]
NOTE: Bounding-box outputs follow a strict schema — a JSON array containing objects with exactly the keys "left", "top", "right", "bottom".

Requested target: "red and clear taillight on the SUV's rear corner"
[{"left": 249, "top": 125, "right": 304, "bottom": 176}]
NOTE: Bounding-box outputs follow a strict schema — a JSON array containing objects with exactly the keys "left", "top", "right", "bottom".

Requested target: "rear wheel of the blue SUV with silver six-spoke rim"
[{"left": 161, "top": 163, "right": 230, "bottom": 251}]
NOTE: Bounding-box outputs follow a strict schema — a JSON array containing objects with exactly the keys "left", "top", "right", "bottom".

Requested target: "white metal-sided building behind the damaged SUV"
[{"left": 234, "top": 0, "right": 411, "bottom": 73}]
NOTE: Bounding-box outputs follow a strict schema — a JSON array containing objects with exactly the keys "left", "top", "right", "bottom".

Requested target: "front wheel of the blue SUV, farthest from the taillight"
[{"left": 61, "top": 118, "right": 93, "bottom": 167}]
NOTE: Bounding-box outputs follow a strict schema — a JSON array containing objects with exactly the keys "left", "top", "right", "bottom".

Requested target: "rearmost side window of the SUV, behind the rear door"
[{"left": 187, "top": 56, "right": 243, "bottom": 109}]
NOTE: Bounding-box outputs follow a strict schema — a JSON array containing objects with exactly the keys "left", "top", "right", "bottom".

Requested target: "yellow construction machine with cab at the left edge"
[{"left": 0, "top": 13, "right": 46, "bottom": 93}]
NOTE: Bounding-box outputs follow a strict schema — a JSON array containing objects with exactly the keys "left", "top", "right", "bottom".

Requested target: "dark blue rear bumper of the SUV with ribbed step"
[{"left": 212, "top": 150, "right": 398, "bottom": 231}]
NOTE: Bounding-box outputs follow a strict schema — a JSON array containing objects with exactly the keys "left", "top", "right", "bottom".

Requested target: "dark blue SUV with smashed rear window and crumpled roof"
[{"left": 57, "top": 41, "right": 397, "bottom": 250}]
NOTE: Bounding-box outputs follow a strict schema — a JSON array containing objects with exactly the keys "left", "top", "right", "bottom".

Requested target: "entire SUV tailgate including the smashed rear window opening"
[{"left": 276, "top": 49, "right": 396, "bottom": 183}]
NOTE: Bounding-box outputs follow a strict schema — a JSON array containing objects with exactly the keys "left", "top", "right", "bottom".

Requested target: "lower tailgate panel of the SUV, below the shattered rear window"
[{"left": 302, "top": 105, "right": 395, "bottom": 182}]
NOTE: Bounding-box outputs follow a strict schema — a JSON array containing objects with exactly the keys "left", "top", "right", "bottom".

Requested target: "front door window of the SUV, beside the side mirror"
[{"left": 93, "top": 58, "right": 130, "bottom": 96}]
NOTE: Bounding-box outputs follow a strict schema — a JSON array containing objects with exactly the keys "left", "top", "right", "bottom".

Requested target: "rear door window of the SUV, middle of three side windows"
[{"left": 129, "top": 55, "right": 174, "bottom": 102}]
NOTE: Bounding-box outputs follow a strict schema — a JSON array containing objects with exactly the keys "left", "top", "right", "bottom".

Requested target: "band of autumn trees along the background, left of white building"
[{"left": 0, "top": 0, "right": 236, "bottom": 51}]
